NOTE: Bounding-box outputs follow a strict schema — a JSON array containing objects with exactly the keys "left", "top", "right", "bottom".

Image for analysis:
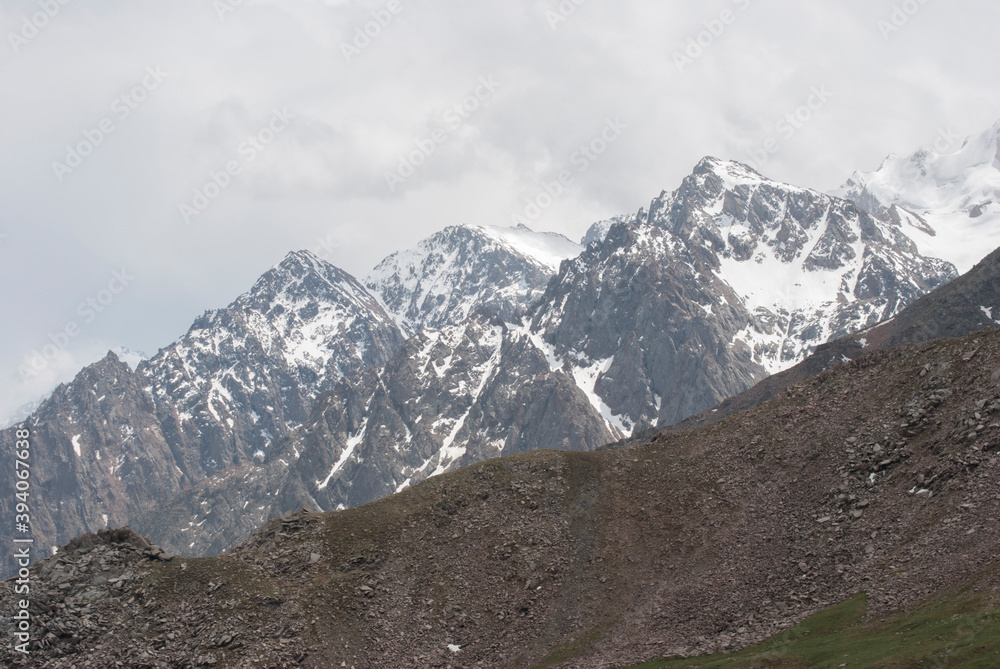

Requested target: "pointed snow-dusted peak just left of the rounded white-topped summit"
[{"left": 139, "top": 251, "right": 403, "bottom": 471}]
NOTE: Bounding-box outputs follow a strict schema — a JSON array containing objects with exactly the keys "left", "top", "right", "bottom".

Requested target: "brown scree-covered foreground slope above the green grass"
[{"left": 0, "top": 331, "right": 1000, "bottom": 669}]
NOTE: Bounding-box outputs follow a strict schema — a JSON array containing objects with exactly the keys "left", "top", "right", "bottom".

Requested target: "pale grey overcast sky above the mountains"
[{"left": 0, "top": 0, "right": 1000, "bottom": 416}]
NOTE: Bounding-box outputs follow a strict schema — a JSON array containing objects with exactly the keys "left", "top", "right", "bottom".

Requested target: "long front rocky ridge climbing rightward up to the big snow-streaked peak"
[{"left": 125, "top": 159, "right": 950, "bottom": 555}]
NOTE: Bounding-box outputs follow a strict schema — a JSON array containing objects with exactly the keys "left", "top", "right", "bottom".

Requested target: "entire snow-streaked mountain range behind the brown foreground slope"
[{"left": 0, "top": 120, "right": 1000, "bottom": 568}]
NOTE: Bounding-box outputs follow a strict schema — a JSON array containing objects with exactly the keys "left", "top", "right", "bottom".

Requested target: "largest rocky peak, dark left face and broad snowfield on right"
[{"left": 531, "top": 158, "right": 956, "bottom": 436}]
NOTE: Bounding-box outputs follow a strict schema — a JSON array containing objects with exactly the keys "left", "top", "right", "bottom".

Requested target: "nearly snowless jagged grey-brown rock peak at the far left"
[{"left": 0, "top": 353, "right": 179, "bottom": 555}]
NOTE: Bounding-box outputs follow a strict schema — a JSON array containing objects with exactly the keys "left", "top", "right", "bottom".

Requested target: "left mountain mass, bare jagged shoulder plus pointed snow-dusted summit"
[{"left": 0, "top": 252, "right": 403, "bottom": 573}]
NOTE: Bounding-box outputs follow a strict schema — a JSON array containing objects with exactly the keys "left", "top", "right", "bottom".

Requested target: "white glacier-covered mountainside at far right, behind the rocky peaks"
[{"left": 834, "top": 117, "right": 1000, "bottom": 272}]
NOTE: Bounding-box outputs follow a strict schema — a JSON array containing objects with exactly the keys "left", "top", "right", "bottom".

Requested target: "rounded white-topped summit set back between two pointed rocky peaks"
[{"left": 364, "top": 225, "right": 583, "bottom": 336}]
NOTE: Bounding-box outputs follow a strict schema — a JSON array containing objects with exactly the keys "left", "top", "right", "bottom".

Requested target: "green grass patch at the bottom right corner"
[{"left": 632, "top": 590, "right": 1000, "bottom": 669}]
